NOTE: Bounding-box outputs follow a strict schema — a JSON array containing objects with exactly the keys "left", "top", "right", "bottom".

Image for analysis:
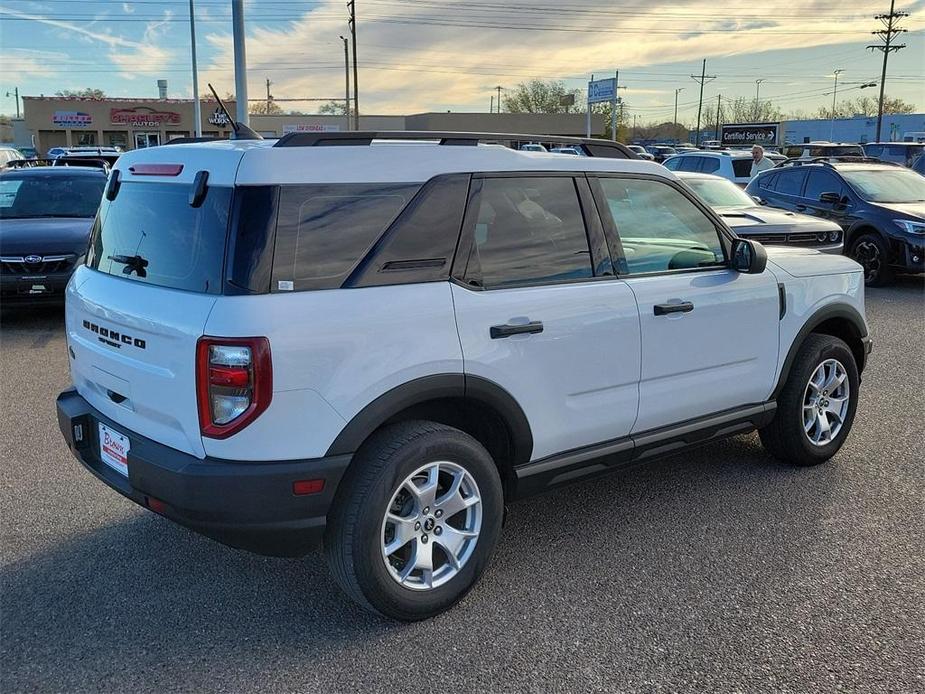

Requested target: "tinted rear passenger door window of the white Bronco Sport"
[{"left": 466, "top": 177, "right": 594, "bottom": 288}]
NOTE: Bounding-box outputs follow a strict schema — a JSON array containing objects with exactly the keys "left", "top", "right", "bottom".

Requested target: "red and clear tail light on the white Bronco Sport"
[{"left": 196, "top": 337, "right": 273, "bottom": 439}]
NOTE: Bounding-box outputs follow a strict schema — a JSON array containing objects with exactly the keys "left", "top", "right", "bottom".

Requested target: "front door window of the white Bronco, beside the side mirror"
[{"left": 599, "top": 178, "right": 726, "bottom": 274}]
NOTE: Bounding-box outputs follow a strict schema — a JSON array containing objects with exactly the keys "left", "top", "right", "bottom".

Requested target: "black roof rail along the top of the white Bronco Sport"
[{"left": 273, "top": 130, "right": 638, "bottom": 159}]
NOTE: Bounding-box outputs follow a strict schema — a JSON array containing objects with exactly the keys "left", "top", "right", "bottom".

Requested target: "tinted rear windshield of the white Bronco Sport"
[{"left": 87, "top": 182, "right": 232, "bottom": 294}]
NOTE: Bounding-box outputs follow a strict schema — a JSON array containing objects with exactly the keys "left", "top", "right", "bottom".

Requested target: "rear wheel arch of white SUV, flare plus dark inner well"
[{"left": 326, "top": 374, "right": 533, "bottom": 491}]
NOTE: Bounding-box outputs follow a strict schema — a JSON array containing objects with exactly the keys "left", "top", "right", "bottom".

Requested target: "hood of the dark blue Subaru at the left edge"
[{"left": 0, "top": 217, "right": 93, "bottom": 256}]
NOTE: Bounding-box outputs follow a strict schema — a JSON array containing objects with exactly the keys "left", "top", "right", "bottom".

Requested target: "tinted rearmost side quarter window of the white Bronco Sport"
[{"left": 271, "top": 183, "right": 420, "bottom": 291}]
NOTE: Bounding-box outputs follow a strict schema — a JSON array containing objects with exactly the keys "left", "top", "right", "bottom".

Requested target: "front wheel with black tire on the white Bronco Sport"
[{"left": 758, "top": 334, "right": 860, "bottom": 466}]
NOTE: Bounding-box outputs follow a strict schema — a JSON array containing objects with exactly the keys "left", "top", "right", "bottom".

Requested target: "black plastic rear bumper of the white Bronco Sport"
[{"left": 57, "top": 389, "right": 351, "bottom": 556}]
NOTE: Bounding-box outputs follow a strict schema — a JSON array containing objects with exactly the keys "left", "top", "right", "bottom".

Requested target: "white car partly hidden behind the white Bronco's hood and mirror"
[{"left": 675, "top": 171, "right": 842, "bottom": 254}]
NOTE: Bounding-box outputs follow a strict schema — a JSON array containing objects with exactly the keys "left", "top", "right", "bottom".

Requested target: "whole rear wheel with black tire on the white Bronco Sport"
[{"left": 324, "top": 421, "right": 504, "bottom": 621}]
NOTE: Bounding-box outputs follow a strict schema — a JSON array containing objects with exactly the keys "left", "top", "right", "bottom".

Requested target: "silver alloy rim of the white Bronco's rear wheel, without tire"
[{"left": 380, "top": 461, "right": 482, "bottom": 590}]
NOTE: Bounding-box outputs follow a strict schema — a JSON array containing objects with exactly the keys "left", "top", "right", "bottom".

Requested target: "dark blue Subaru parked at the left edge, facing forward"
[{"left": 0, "top": 166, "right": 106, "bottom": 306}]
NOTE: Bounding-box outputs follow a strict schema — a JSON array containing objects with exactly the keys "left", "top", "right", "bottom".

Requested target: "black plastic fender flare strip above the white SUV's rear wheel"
[{"left": 325, "top": 373, "right": 533, "bottom": 465}]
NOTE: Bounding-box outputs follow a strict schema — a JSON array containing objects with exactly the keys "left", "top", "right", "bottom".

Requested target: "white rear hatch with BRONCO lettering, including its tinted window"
[{"left": 66, "top": 145, "right": 242, "bottom": 457}]
